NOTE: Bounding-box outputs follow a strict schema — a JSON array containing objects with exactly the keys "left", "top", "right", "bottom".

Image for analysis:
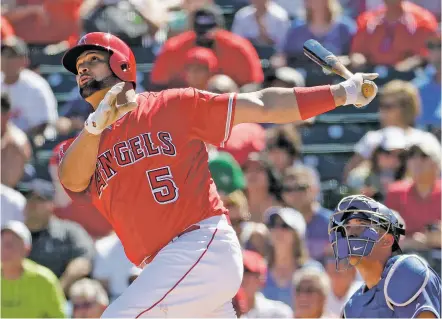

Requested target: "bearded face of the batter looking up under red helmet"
[{"left": 76, "top": 50, "right": 120, "bottom": 99}]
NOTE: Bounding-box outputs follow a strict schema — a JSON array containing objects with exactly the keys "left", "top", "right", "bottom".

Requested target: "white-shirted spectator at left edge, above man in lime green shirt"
[{"left": 0, "top": 184, "right": 26, "bottom": 225}]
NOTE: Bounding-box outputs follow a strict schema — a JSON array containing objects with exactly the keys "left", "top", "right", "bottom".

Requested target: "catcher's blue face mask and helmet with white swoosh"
[{"left": 328, "top": 195, "right": 405, "bottom": 271}]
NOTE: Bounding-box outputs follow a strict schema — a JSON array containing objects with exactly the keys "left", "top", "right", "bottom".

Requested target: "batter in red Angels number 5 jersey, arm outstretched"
[{"left": 59, "top": 33, "right": 377, "bottom": 318}]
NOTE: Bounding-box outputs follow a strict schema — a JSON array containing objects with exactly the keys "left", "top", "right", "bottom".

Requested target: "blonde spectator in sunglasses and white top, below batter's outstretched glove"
[{"left": 344, "top": 80, "right": 428, "bottom": 181}]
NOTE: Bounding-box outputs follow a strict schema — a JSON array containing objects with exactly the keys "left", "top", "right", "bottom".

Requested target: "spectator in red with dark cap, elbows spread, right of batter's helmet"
[{"left": 151, "top": 7, "right": 264, "bottom": 87}]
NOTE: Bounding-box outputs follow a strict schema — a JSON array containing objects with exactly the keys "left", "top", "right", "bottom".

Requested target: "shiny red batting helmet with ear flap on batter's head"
[{"left": 62, "top": 32, "right": 137, "bottom": 85}]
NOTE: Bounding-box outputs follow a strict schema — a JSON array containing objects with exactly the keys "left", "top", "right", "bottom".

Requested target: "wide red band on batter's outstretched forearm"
[{"left": 294, "top": 85, "right": 336, "bottom": 120}]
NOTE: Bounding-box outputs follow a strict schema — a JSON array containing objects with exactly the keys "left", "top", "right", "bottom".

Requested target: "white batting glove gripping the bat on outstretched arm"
[{"left": 340, "top": 73, "right": 379, "bottom": 107}]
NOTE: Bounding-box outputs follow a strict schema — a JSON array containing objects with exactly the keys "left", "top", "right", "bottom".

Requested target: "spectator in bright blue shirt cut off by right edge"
[{"left": 412, "top": 35, "right": 442, "bottom": 131}]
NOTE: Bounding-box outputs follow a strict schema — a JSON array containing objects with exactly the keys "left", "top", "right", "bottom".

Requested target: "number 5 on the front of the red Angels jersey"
[{"left": 146, "top": 166, "right": 178, "bottom": 204}]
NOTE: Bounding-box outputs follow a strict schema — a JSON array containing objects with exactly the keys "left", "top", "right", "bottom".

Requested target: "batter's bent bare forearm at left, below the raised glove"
[{"left": 58, "top": 129, "right": 101, "bottom": 192}]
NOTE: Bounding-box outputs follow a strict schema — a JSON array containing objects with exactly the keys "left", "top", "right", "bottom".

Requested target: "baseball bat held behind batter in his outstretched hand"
[{"left": 304, "top": 39, "right": 376, "bottom": 98}]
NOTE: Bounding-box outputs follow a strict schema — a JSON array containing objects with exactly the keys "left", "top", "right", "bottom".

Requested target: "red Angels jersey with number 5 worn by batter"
[{"left": 60, "top": 88, "right": 236, "bottom": 265}]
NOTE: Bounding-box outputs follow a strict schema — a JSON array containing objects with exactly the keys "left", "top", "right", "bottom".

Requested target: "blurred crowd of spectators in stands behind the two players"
[{"left": 0, "top": 0, "right": 442, "bottom": 318}]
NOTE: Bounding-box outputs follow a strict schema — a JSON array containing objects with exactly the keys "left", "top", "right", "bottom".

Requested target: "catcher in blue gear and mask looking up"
[{"left": 329, "top": 195, "right": 442, "bottom": 318}]
